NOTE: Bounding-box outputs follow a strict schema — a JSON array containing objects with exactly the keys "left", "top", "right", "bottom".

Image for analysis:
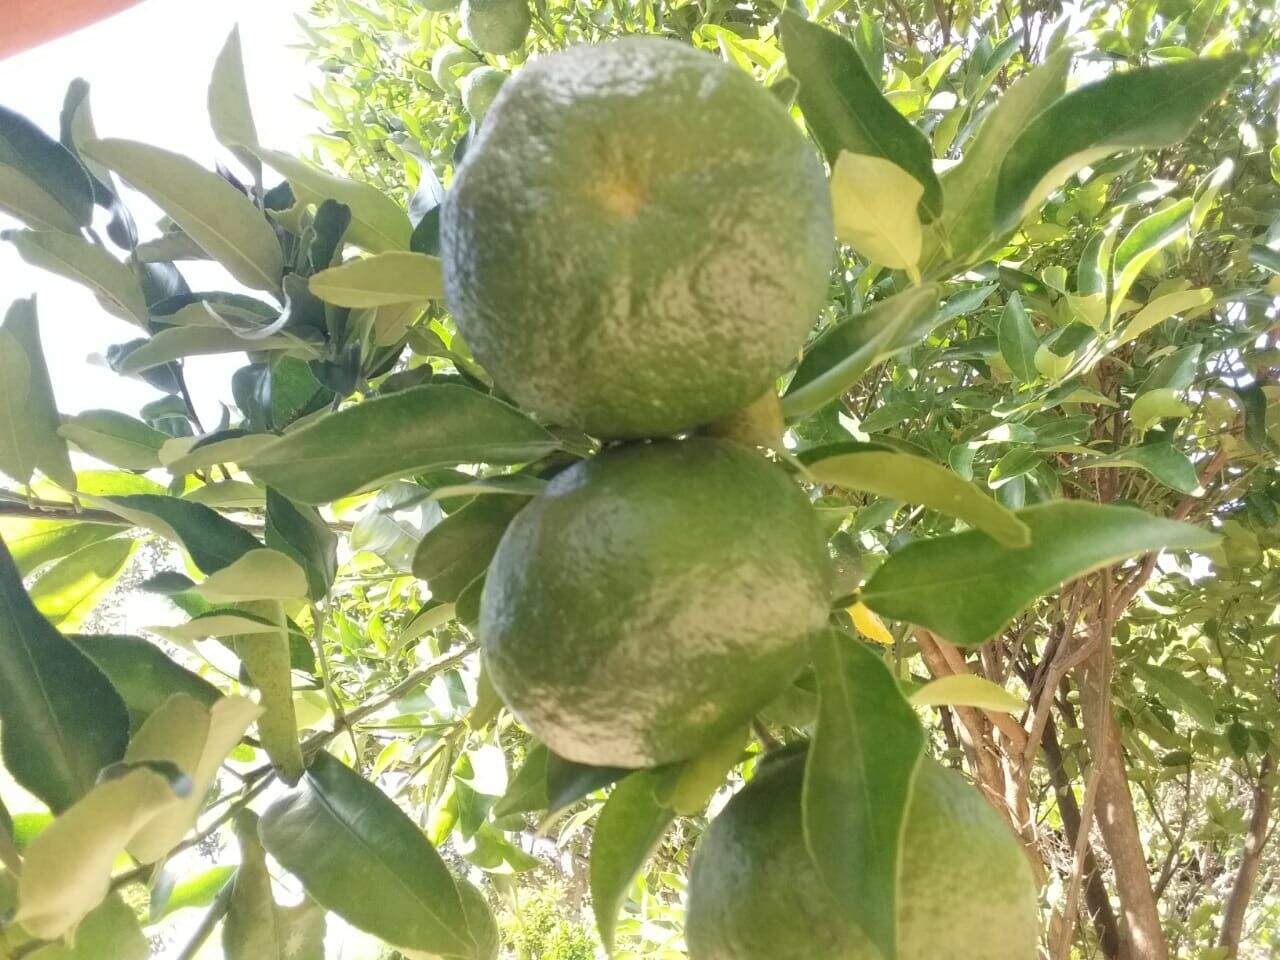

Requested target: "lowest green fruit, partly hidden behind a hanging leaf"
[{"left": 685, "top": 751, "right": 1039, "bottom": 960}]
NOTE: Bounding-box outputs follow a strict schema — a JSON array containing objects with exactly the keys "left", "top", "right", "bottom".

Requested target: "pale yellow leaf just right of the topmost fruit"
[{"left": 831, "top": 151, "right": 924, "bottom": 271}]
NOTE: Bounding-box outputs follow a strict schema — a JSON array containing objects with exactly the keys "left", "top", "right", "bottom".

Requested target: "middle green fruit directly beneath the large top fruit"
[{"left": 480, "top": 439, "right": 828, "bottom": 767}]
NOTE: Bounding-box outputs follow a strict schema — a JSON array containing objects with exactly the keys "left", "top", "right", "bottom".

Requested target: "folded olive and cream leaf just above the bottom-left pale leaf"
[{"left": 124, "top": 694, "right": 262, "bottom": 863}]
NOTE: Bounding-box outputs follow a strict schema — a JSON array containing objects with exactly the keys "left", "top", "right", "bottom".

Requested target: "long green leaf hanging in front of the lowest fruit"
[{"left": 804, "top": 630, "right": 924, "bottom": 960}]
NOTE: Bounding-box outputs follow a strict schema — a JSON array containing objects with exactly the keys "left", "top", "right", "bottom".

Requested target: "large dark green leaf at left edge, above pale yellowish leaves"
[{"left": 0, "top": 543, "right": 129, "bottom": 813}]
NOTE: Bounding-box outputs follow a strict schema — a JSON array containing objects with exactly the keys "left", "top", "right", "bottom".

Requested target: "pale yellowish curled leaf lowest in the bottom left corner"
[{"left": 14, "top": 767, "right": 180, "bottom": 940}]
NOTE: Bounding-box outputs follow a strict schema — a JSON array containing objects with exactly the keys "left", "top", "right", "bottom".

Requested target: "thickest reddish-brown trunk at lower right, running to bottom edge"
[{"left": 1079, "top": 650, "right": 1169, "bottom": 960}]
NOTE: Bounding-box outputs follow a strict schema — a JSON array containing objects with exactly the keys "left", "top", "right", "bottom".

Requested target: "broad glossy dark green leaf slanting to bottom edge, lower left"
[{"left": 260, "top": 753, "right": 480, "bottom": 959}]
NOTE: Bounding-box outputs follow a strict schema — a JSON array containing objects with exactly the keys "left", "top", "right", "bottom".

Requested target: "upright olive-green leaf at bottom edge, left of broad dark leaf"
[{"left": 223, "top": 810, "right": 325, "bottom": 960}]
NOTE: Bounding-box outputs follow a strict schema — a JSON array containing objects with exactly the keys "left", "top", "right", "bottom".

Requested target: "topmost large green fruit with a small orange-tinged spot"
[{"left": 442, "top": 37, "right": 835, "bottom": 439}]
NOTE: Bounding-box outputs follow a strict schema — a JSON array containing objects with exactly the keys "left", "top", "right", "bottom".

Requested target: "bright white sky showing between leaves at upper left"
[{"left": 0, "top": 0, "right": 320, "bottom": 424}]
